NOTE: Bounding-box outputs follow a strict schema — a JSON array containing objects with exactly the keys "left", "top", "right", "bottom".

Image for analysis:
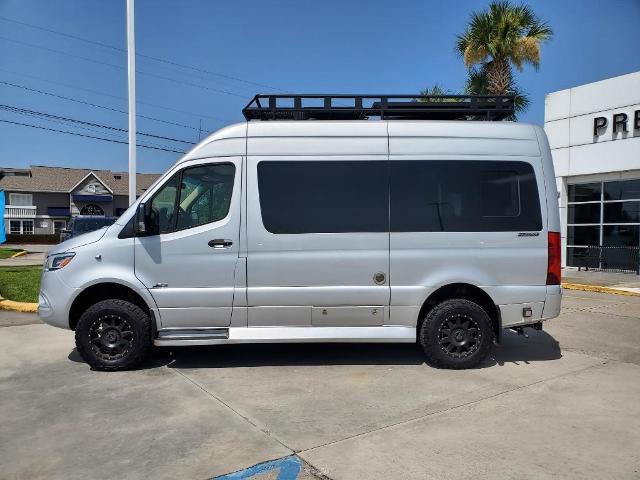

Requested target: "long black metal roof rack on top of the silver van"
[{"left": 242, "top": 94, "right": 514, "bottom": 120}]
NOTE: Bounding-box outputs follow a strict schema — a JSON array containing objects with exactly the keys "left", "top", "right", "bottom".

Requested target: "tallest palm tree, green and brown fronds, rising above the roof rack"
[{"left": 456, "top": 0, "right": 553, "bottom": 95}]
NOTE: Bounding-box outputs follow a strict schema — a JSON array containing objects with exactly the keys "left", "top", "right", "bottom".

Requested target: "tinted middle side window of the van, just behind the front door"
[{"left": 258, "top": 160, "right": 389, "bottom": 234}]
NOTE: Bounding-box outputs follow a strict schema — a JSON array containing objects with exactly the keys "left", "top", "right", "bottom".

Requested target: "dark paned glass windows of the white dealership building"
[{"left": 567, "top": 179, "right": 640, "bottom": 269}]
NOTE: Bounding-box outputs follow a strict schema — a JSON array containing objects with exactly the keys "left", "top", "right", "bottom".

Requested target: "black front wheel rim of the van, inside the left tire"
[{"left": 89, "top": 315, "right": 134, "bottom": 361}]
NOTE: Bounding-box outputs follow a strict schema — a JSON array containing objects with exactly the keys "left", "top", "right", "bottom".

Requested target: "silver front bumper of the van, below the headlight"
[{"left": 38, "top": 270, "right": 77, "bottom": 329}]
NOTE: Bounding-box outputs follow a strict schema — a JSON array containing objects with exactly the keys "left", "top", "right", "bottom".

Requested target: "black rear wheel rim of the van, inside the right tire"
[{"left": 438, "top": 313, "right": 482, "bottom": 358}]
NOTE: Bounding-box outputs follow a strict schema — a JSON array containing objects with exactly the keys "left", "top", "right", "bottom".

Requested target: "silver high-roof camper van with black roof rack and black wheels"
[{"left": 38, "top": 95, "right": 562, "bottom": 370}]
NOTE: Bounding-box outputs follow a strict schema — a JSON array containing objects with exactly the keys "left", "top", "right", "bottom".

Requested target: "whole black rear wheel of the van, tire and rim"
[{"left": 419, "top": 298, "right": 493, "bottom": 369}]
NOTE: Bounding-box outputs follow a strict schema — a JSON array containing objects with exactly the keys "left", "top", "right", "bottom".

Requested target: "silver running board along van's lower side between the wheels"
[{"left": 153, "top": 326, "right": 416, "bottom": 347}]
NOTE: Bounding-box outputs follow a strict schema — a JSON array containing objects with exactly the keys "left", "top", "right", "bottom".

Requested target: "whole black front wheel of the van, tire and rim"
[{"left": 76, "top": 299, "right": 151, "bottom": 371}]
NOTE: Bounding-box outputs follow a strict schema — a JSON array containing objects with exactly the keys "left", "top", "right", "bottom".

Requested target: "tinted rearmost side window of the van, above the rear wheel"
[{"left": 391, "top": 160, "right": 542, "bottom": 232}]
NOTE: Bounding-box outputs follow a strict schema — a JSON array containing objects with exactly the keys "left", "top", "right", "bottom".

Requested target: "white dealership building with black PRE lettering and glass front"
[{"left": 544, "top": 72, "right": 640, "bottom": 270}]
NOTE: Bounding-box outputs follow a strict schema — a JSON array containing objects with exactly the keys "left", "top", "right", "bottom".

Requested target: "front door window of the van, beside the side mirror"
[{"left": 146, "top": 163, "right": 235, "bottom": 235}]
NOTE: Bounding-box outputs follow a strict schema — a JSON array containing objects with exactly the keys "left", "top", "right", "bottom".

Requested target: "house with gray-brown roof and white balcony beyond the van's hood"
[{"left": 0, "top": 165, "right": 160, "bottom": 240}]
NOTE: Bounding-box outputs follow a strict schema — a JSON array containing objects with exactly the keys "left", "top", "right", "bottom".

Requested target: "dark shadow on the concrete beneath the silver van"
[{"left": 69, "top": 329, "right": 562, "bottom": 369}]
